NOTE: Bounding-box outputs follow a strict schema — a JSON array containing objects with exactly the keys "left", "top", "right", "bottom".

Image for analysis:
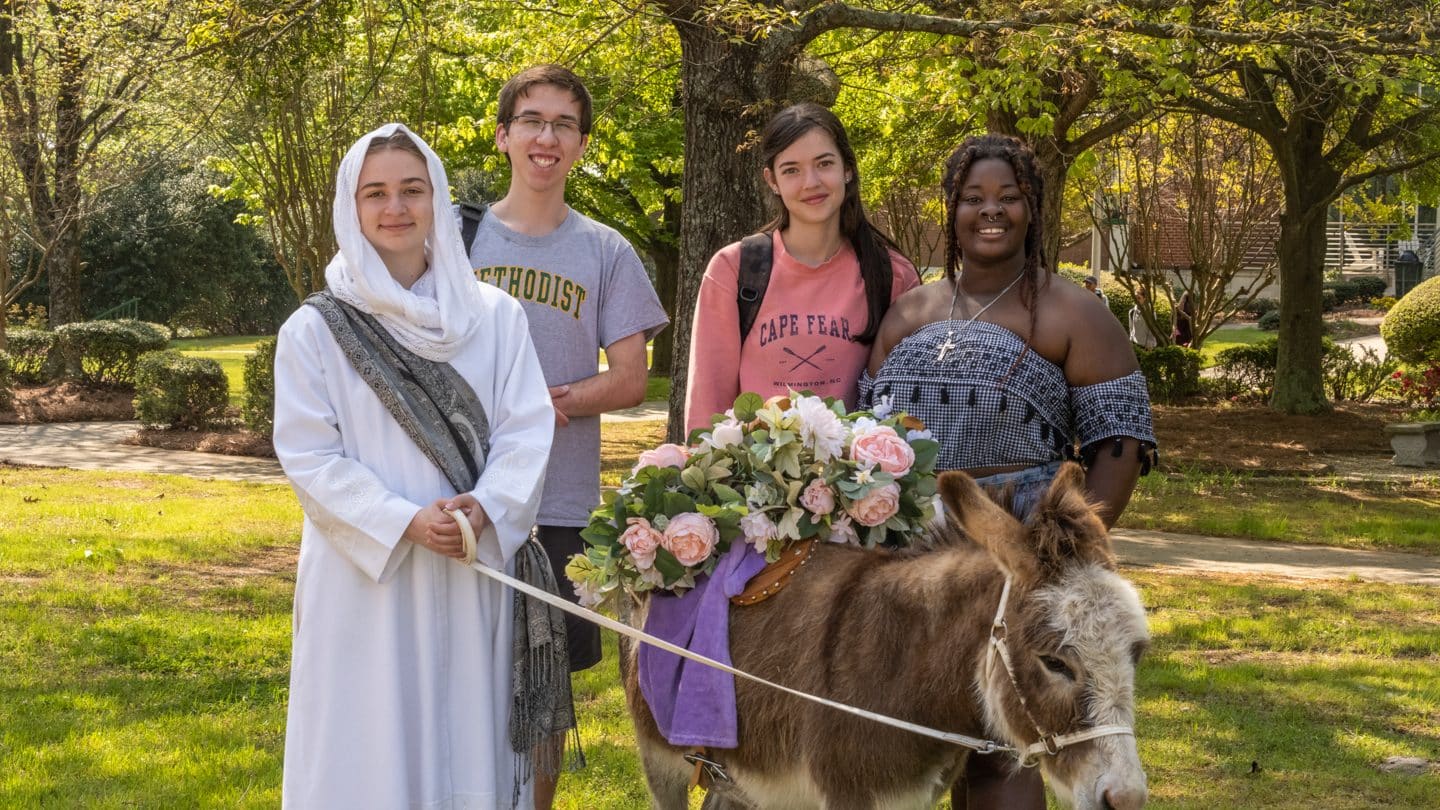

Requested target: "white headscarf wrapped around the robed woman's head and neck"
[{"left": 325, "top": 124, "right": 482, "bottom": 362}]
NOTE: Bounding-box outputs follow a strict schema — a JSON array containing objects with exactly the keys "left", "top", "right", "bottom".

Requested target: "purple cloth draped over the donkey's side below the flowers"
[{"left": 639, "top": 538, "right": 765, "bottom": 748}]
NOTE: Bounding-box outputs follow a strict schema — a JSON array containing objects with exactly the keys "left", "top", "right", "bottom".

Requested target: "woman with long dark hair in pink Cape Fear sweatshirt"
[{"left": 685, "top": 102, "right": 920, "bottom": 431}]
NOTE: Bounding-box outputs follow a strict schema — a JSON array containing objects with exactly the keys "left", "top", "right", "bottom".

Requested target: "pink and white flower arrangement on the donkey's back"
[{"left": 566, "top": 393, "right": 940, "bottom": 605}]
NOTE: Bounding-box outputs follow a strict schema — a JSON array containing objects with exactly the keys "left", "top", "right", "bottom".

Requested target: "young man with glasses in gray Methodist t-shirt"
[{"left": 469, "top": 65, "right": 668, "bottom": 809}]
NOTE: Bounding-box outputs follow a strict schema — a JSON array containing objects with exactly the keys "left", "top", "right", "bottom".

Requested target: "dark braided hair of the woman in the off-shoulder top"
[{"left": 940, "top": 133, "right": 1045, "bottom": 349}]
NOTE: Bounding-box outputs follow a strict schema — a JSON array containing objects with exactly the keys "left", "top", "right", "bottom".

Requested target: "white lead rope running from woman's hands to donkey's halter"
[{"left": 449, "top": 510, "right": 1135, "bottom": 764}]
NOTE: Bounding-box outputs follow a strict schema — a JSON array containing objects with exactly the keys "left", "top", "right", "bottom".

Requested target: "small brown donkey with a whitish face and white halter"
[{"left": 622, "top": 464, "right": 1149, "bottom": 810}]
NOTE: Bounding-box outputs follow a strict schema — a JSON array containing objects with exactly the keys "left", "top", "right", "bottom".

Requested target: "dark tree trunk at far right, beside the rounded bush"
[{"left": 1270, "top": 204, "right": 1331, "bottom": 414}]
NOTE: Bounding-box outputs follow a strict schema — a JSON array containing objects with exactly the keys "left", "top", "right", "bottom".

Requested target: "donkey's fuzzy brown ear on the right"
[{"left": 1030, "top": 461, "right": 1115, "bottom": 574}]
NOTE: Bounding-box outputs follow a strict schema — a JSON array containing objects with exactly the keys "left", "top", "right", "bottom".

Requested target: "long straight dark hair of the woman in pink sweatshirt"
[{"left": 760, "top": 101, "right": 900, "bottom": 346}]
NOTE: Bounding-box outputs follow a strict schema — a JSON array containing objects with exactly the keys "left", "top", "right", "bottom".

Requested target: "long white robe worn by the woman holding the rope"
[{"left": 275, "top": 275, "right": 554, "bottom": 810}]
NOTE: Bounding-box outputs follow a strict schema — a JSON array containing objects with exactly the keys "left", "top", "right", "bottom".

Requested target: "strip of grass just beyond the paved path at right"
[{"left": 1119, "top": 468, "right": 1440, "bottom": 553}]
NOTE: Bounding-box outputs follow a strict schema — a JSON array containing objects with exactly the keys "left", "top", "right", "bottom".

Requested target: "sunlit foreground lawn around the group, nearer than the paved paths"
[{"left": 0, "top": 467, "right": 1440, "bottom": 810}]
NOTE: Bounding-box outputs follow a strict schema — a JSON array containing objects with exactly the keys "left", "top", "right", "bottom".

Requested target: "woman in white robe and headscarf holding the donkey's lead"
[{"left": 275, "top": 124, "right": 554, "bottom": 810}]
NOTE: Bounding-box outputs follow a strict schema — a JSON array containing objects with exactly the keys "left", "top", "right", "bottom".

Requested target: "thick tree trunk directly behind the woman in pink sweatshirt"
[{"left": 667, "top": 3, "right": 789, "bottom": 441}]
